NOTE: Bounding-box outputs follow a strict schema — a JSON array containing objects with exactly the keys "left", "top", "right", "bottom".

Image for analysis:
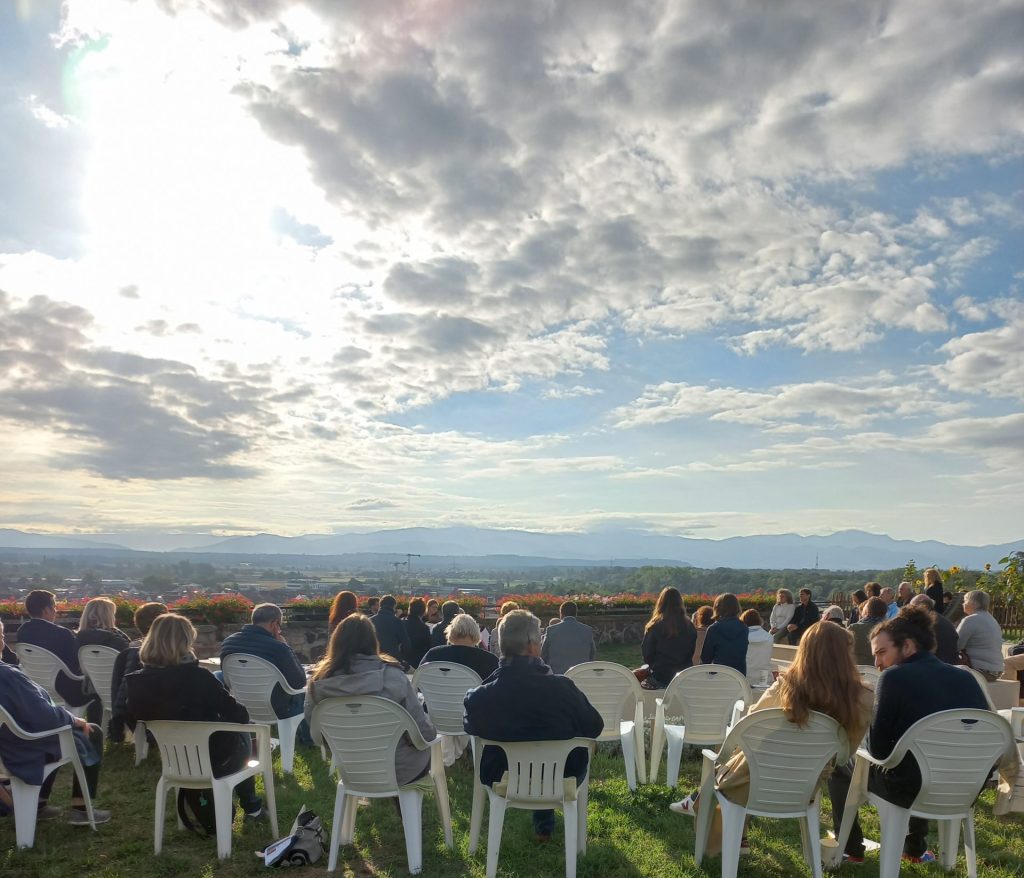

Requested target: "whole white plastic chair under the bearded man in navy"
[{"left": 837, "top": 708, "right": 1014, "bottom": 878}]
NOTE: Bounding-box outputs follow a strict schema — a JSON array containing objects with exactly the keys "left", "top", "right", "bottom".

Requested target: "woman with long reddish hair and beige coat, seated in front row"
[{"left": 669, "top": 623, "right": 872, "bottom": 855}]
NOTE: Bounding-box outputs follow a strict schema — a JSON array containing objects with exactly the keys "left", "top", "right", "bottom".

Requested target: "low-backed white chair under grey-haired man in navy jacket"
[{"left": 470, "top": 738, "right": 595, "bottom": 878}]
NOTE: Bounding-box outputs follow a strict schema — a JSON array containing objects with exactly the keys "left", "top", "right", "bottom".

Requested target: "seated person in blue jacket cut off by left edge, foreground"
[{"left": 0, "top": 622, "right": 111, "bottom": 823}]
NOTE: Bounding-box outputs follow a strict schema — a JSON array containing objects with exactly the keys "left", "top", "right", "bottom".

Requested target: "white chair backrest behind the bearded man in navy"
[{"left": 890, "top": 709, "right": 1014, "bottom": 814}]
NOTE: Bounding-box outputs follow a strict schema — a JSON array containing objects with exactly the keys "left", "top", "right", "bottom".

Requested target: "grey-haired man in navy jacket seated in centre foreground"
[{"left": 463, "top": 610, "right": 604, "bottom": 842}]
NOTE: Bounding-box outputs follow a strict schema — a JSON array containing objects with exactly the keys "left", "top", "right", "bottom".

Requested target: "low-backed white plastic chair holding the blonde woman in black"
[{"left": 143, "top": 719, "right": 279, "bottom": 860}]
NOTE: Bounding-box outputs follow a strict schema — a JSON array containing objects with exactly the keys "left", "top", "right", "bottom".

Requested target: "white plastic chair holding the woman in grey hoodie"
[{"left": 309, "top": 696, "right": 454, "bottom": 875}]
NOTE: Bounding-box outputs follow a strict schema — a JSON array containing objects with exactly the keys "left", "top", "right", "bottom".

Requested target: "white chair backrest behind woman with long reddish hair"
[{"left": 722, "top": 707, "right": 841, "bottom": 813}]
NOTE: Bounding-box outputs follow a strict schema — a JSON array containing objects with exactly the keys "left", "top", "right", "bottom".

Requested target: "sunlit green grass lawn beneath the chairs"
[{"left": 0, "top": 646, "right": 1024, "bottom": 878}]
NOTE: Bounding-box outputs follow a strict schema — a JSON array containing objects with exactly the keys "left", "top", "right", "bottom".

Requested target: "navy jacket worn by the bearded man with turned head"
[{"left": 867, "top": 653, "right": 988, "bottom": 804}]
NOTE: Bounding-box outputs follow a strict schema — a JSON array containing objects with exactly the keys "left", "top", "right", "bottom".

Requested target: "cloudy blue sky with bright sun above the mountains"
[{"left": 0, "top": 0, "right": 1024, "bottom": 545}]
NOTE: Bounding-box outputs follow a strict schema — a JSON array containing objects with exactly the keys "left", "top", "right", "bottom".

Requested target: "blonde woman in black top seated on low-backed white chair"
[{"left": 125, "top": 613, "right": 263, "bottom": 819}]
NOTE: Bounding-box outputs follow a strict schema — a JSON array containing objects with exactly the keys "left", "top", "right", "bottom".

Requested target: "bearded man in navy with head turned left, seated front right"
[{"left": 828, "top": 607, "right": 988, "bottom": 863}]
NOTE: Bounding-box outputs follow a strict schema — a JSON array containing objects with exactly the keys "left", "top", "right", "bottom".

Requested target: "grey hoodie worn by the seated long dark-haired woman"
[{"left": 304, "top": 656, "right": 437, "bottom": 786}]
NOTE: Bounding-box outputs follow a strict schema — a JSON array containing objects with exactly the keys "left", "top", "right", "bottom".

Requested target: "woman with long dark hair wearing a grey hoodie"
[{"left": 305, "top": 613, "right": 437, "bottom": 787}]
